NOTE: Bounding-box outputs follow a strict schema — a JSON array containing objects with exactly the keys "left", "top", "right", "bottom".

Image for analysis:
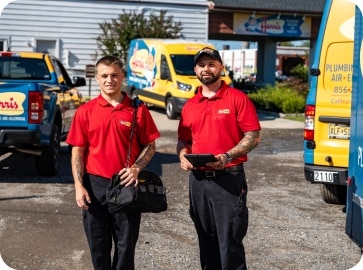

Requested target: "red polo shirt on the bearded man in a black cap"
[{"left": 178, "top": 81, "right": 261, "bottom": 166}]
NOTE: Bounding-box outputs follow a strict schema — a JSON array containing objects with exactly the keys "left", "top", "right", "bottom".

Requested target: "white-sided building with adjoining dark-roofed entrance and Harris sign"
[{"left": 0, "top": 0, "right": 325, "bottom": 96}]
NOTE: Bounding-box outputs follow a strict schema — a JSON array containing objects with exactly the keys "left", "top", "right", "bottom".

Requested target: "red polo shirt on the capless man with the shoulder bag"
[{"left": 66, "top": 94, "right": 160, "bottom": 178}]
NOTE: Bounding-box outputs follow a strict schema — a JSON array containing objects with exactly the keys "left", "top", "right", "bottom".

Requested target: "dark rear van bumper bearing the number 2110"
[{"left": 304, "top": 165, "right": 348, "bottom": 185}]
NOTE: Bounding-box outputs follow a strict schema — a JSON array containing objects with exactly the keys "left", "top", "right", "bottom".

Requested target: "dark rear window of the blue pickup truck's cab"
[{"left": 0, "top": 56, "right": 50, "bottom": 80}]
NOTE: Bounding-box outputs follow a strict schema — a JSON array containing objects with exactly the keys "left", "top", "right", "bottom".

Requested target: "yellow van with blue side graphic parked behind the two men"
[{"left": 126, "top": 39, "right": 232, "bottom": 119}]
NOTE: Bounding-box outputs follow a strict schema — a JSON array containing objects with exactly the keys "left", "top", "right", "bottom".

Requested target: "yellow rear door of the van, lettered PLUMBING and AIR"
[{"left": 314, "top": 1, "right": 354, "bottom": 170}]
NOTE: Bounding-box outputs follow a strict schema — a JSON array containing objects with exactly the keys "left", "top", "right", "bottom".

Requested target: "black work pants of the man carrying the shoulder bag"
[{"left": 83, "top": 175, "right": 141, "bottom": 270}]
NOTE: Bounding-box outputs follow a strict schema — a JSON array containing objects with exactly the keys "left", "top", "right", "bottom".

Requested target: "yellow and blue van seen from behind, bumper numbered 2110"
[{"left": 304, "top": 0, "right": 355, "bottom": 204}]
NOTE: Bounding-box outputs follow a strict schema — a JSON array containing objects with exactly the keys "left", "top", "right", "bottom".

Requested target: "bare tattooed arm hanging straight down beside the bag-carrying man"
[{"left": 71, "top": 146, "right": 91, "bottom": 210}]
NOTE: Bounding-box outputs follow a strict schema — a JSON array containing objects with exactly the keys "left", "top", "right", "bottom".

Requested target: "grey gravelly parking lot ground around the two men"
[{"left": 0, "top": 111, "right": 361, "bottom": 270}]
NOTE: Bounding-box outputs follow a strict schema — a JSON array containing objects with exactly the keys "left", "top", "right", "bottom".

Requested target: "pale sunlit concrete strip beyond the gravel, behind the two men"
[{"left": 150, "top": 109, "right": 304, "bottom": 131}]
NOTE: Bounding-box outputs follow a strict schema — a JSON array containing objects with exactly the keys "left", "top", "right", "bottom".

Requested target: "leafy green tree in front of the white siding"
[{"left": 95, "top": 10, "right": 182, "bottom": 63}]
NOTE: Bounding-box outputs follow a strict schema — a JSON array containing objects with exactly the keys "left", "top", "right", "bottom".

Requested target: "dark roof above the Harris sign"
[{"left": 213, "top": 0, "right": 325, "bottom": 14}]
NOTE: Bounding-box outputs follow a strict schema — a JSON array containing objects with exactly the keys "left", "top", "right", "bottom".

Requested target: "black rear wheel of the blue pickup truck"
[{"left": 35, "top": 125, "right": 60, "bottom": 176}]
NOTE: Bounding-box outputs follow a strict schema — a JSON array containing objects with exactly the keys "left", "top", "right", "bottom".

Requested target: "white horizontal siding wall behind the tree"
[{"left": 0, "top": 0, "right": 208, "bottom": 97}]
